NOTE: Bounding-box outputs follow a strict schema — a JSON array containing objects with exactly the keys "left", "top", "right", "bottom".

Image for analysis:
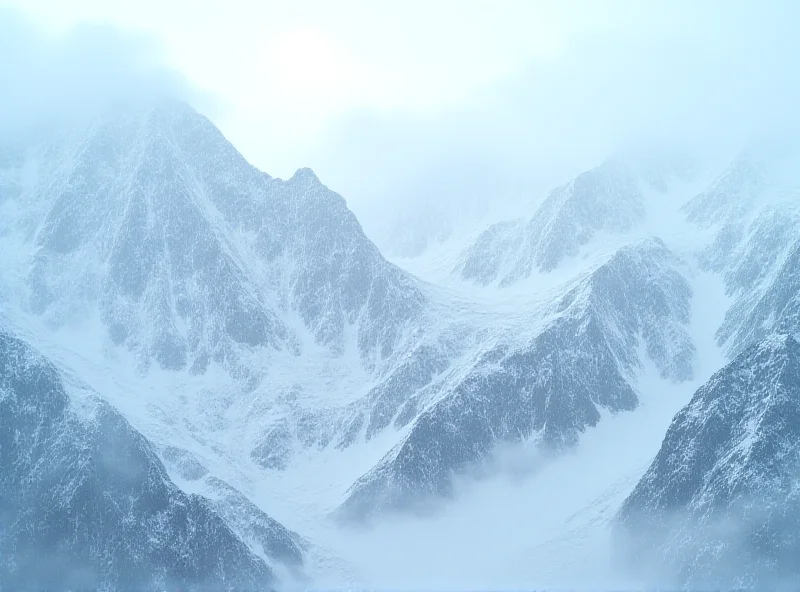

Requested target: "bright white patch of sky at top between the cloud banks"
[{"left": 0, "top": 0, "right": 732, "bottom": 175}]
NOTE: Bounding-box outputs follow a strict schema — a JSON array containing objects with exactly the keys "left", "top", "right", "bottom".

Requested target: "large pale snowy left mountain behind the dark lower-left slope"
[{"left": 0, "top": 101, "right": 426, "bottom": 587}]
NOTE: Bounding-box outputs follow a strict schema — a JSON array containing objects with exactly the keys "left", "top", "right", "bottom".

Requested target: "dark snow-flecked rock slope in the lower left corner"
[{"left": 0, "top": 332, "right": 298, "bottom": 590}]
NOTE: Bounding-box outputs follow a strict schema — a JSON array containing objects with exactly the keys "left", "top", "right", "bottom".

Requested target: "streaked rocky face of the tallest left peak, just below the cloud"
[{"left": 21, "top": 102, "right": 289, "bottom": 372}]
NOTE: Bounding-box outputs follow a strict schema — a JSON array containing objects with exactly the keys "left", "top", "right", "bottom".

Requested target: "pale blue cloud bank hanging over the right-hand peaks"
[{"left": 308, "top": 1, "right": 800, "bottom": 254}]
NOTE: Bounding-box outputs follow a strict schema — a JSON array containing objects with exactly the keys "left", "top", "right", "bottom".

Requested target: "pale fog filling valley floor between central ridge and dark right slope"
[{"left": 306, "top": 377, "right": 690, "bottom": 591}]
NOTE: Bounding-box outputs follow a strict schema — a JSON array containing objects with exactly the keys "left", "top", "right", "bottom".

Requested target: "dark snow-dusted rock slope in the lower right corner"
[{"left": 616, "top": 335, "right": 800, "bottom": 589}]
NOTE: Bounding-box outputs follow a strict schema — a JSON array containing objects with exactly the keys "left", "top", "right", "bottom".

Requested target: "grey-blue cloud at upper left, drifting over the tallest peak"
[{"left": 0, "top": 6, "right": 218, "bottom": 138}]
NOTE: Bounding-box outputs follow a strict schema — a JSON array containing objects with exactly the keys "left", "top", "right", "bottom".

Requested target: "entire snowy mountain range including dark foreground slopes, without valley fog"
[{"left": 0, "top": 100, "right": 800, "bottom": 590}]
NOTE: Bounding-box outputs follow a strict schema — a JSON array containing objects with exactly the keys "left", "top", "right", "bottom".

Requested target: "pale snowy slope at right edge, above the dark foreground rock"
[{"left": 684, "top": 151, "right": 800, "bottom": 356}]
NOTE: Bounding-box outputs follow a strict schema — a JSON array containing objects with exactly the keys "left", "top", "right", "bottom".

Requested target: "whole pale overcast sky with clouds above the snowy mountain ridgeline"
[{"left": 0, "top": 0, "right": 800, "bottom": 252}]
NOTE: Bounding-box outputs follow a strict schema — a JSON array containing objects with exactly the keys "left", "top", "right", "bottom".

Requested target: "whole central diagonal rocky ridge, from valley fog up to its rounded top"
[{"left": 339, "top": 239, "right": 694, "bottom": 519}]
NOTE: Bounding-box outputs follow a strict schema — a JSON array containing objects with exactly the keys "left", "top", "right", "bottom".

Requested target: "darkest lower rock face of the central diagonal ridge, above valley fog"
[{"left": 341, "top": 320, "right": 637, "bottom": 519}]
